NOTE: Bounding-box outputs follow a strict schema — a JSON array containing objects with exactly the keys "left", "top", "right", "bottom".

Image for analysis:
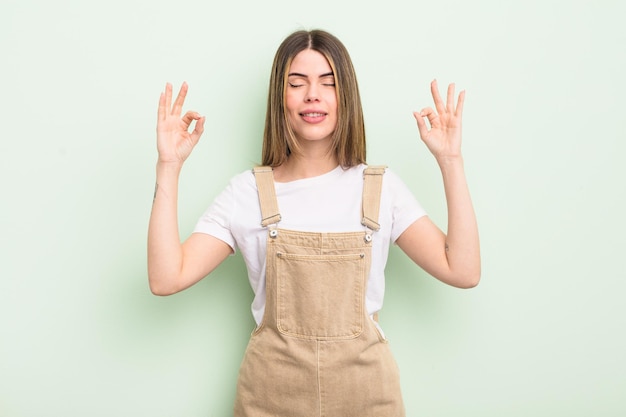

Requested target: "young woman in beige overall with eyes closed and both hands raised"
[{"left": 148, "top": 30, "right": 480, "bottom": 417}]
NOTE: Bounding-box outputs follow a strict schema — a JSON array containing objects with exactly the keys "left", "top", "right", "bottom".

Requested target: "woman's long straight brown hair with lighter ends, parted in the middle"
[{"left": 262, "top": 30, "right": 366, "bottom": 168}]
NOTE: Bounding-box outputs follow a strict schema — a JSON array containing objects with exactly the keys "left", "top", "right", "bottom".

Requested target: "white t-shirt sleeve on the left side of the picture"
[{"left": 193, "top": 181, "right": 237, "bottom": 253}]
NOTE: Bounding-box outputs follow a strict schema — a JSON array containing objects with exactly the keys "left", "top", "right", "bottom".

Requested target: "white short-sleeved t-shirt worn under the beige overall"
[{"left": 194, "top": 165, "right": 426, "bottom": 324}]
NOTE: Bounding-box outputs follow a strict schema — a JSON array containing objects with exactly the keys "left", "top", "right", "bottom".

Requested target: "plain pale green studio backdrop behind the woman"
[{"left": 0, "top": 0, "right": 626, "bottom": 417}]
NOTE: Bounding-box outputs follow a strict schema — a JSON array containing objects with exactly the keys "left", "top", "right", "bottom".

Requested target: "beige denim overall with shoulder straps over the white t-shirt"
[{"left": 235, "top": 167, "right": 404, "bottom": 417}]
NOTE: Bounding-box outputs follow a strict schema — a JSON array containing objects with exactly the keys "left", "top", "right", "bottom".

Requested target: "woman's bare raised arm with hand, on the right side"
[{"left": 396, "top": 81, "right": 480, "bottom": 288}]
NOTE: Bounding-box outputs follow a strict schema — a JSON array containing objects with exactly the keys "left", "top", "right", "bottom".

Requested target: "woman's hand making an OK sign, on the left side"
[{"left": 157, "top": 83, "right": 205, "bottom": 166}]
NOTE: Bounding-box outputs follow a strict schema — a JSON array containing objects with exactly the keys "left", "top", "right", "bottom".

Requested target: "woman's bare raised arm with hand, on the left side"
[{"left": 148, "top": 83, "right": 232, "bottom": 295}]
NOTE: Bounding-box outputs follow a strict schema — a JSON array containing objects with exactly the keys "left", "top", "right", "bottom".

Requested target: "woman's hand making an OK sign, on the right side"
[{"left": 413, "top": 80, "right": 465, "bottom": 163}]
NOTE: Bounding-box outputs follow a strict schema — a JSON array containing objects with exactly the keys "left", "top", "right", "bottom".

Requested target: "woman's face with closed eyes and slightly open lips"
[{"left": 285, "top": 49, "right": 337, "bottom": 146}]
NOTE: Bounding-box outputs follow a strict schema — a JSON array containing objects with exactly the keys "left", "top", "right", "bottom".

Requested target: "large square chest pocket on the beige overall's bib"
[{"left": 276, "top": 252, "right": 368, "bottom": 340}]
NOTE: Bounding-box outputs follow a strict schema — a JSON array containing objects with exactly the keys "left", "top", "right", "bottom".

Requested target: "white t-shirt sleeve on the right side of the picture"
[{"left": 383, "top": 169, "right": 426, "bottom": 243}]
